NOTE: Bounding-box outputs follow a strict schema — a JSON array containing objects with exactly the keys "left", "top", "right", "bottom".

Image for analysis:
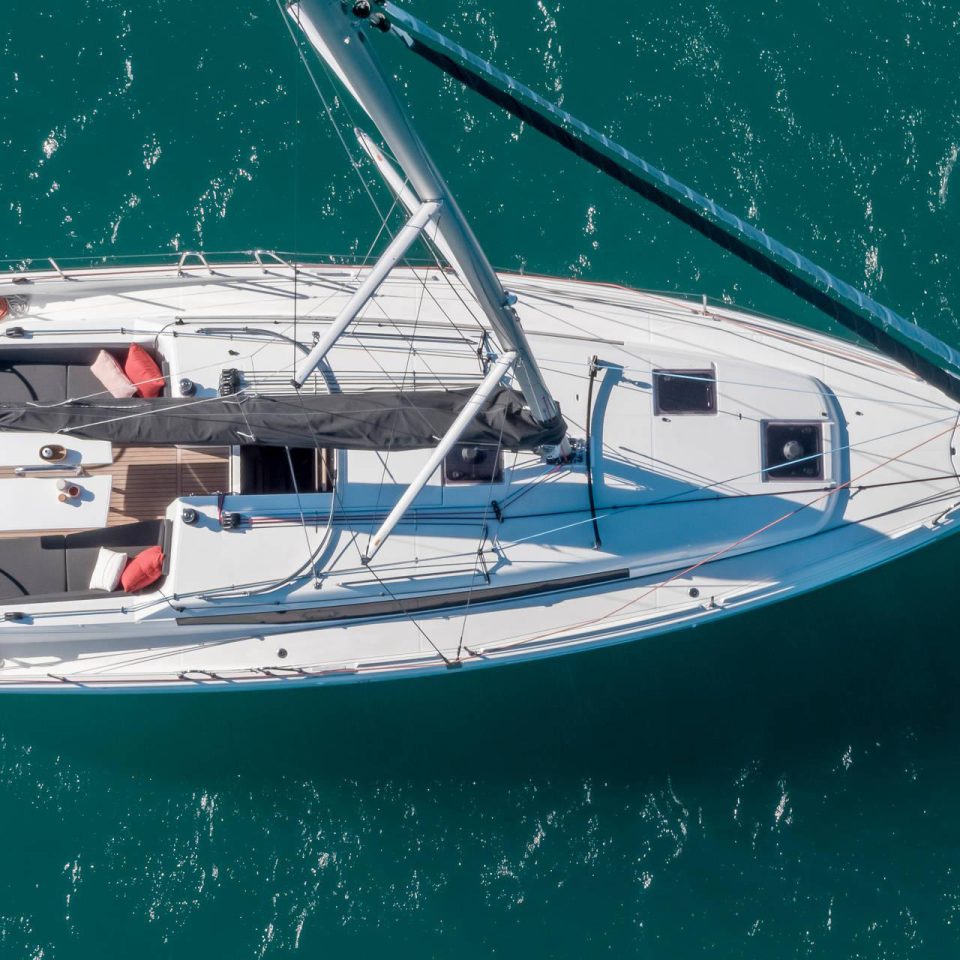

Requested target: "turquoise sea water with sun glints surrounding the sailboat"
[{"left": 0, "top": 0, "right": 960, "bottom": 960}]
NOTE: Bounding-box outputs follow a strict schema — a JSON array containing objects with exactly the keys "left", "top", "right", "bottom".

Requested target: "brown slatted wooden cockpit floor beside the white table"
[{"left": 0, "top": 446, "right": 230, "bottom": 537}]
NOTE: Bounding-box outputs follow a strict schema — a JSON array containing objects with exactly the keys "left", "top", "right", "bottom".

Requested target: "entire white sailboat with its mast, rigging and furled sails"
[{"left": 0, "top": 0, "right": 960, "bottom": 692}]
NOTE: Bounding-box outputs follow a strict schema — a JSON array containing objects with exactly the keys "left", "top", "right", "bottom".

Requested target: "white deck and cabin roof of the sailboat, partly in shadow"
[{"left": 0, "top": 258, "right": 960, "bottom": 686}]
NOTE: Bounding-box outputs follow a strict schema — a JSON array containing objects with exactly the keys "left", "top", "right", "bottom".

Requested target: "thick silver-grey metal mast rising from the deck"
[{"left": 287, "top": 0, "right": 561, "bottom": 436}]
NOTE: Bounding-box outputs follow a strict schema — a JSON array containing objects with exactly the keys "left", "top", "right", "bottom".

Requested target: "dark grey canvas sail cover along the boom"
[{"left": 0, "top": 387, "right": 566, "bottom": 450}]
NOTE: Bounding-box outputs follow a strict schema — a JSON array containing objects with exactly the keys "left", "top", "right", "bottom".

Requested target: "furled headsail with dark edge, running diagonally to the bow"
[{"left": 376, "top": 3, "right": 960, "bottom": 402}]
